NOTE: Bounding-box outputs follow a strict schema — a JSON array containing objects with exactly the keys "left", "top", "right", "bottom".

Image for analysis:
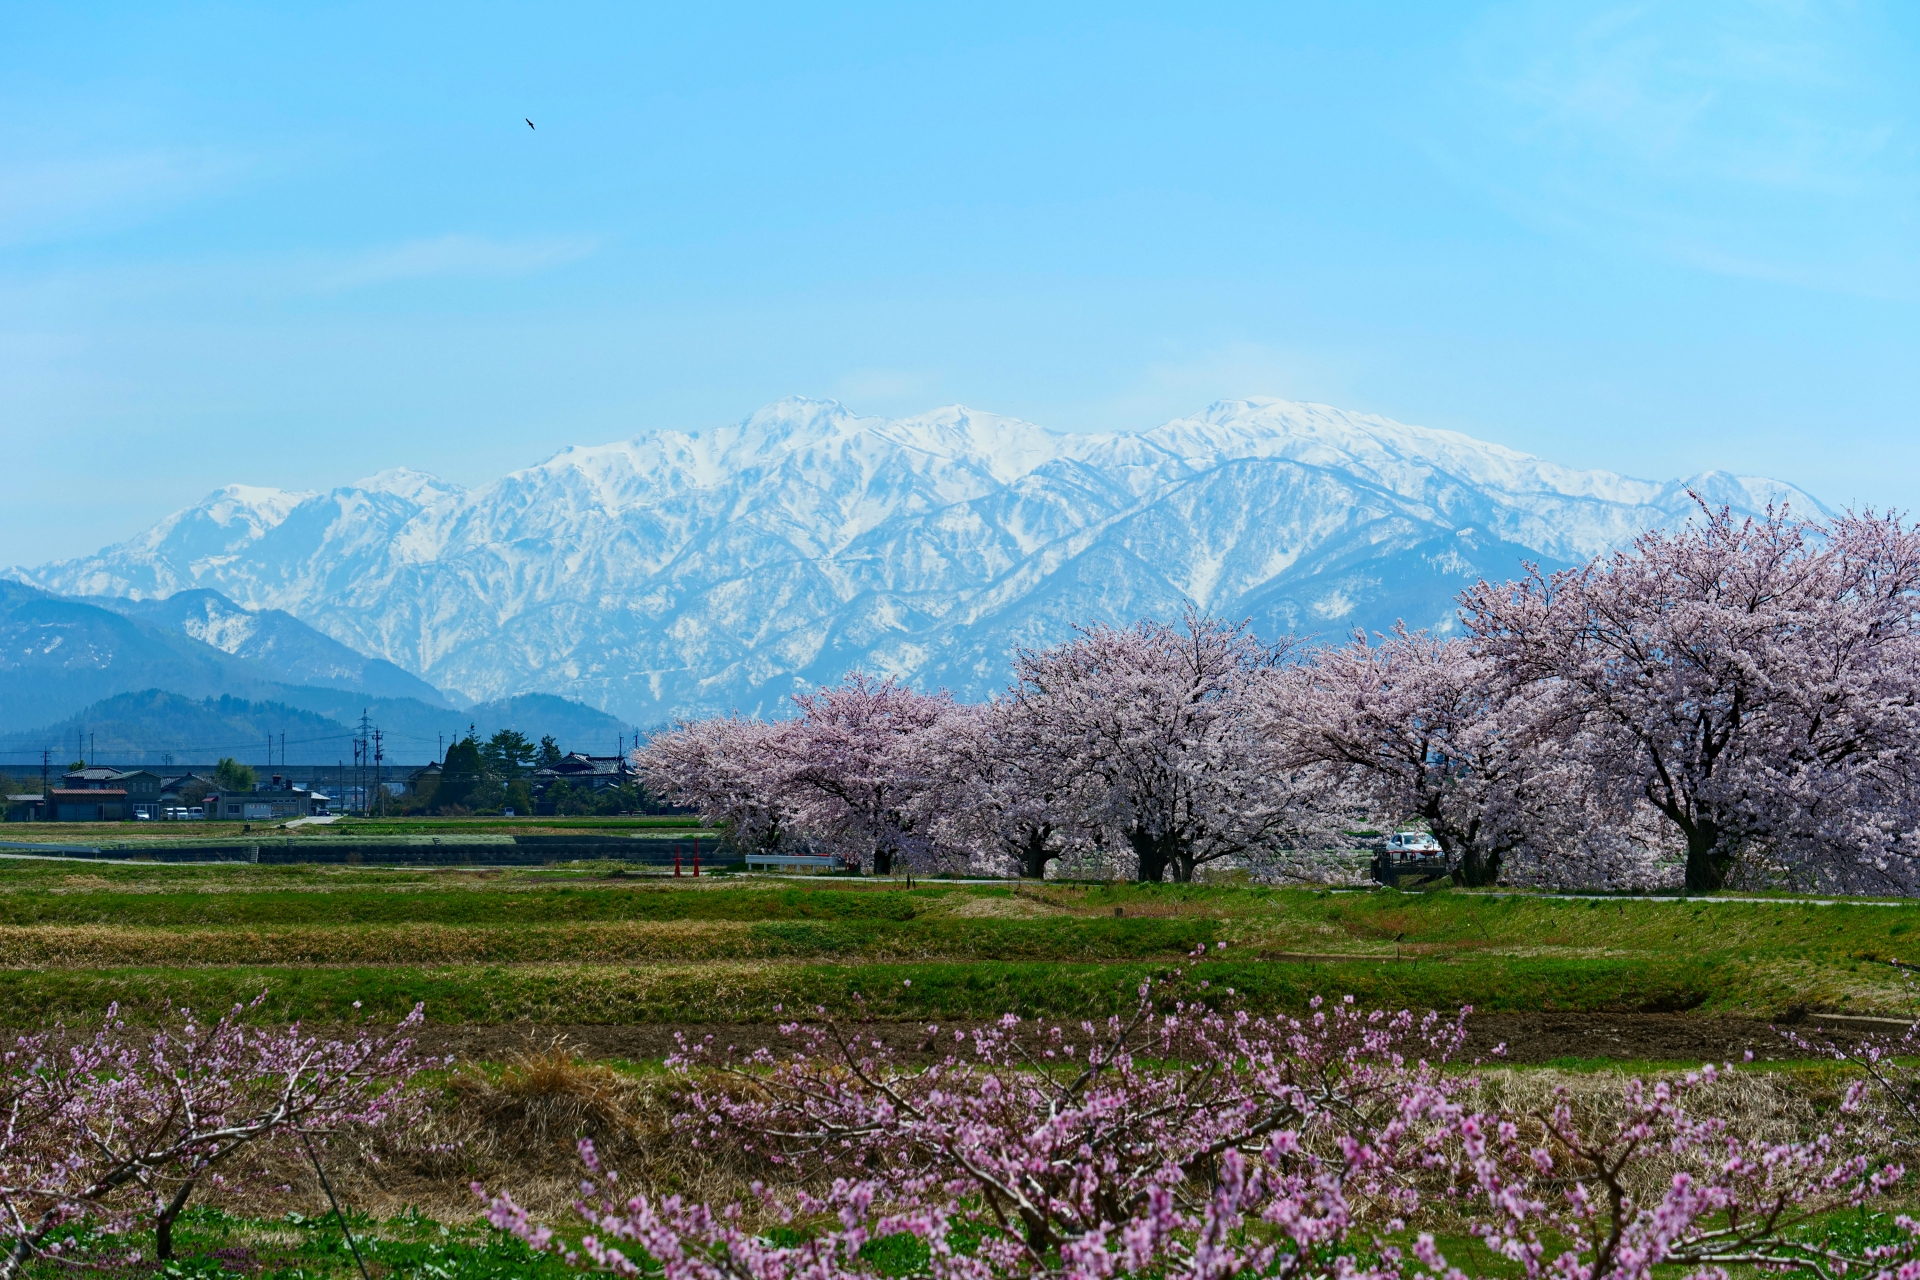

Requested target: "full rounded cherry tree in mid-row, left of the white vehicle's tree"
[{"left": 1012, "top": 606, "right": 1311, "bottom": 881}]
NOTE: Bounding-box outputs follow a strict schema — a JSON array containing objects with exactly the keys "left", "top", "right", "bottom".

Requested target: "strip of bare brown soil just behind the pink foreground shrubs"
[{"left": 408, "top": 1013, "right": 1901, "bottom": 1063}]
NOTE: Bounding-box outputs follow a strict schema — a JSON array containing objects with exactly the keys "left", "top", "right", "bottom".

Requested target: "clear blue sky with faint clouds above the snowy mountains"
[{"left": 0, "top": 0, "right": 1920, "bottom": 564}]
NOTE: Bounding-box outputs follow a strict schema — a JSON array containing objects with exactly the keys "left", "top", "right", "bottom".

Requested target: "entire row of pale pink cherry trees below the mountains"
[{"left": 637, "top": 509, "right": 1920, "bottom": 889}]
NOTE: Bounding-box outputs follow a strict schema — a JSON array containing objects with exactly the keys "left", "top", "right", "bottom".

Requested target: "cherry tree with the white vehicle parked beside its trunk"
[{"left": 1267, "top": 626, "right": 1592, "bottom": 885}]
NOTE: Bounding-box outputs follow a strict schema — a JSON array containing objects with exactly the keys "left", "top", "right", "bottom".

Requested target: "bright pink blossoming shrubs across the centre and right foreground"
[{"left": 474, "top": 967, "right": 1920, "bottom": 1280}]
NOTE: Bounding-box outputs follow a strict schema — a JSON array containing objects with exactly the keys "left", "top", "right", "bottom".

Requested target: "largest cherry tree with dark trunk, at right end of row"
[{"left": 1461, "top": 507, "right": 1920, "bottom": 889}]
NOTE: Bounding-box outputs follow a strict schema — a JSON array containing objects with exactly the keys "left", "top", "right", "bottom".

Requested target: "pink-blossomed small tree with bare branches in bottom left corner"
[{"left": 0, "top": 1002, "right": 440, "bottom": 1280}]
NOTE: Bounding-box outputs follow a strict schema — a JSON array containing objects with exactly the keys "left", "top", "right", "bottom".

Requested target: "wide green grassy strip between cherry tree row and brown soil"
[{"left": 0, "top": 860, "right": 1920, "bottom": 1025}]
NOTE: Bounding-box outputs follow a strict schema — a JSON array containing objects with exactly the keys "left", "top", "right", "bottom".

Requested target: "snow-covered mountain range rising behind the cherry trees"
[{"left": 15, "top": 399, "right": 1822, "bottom": 723}]
